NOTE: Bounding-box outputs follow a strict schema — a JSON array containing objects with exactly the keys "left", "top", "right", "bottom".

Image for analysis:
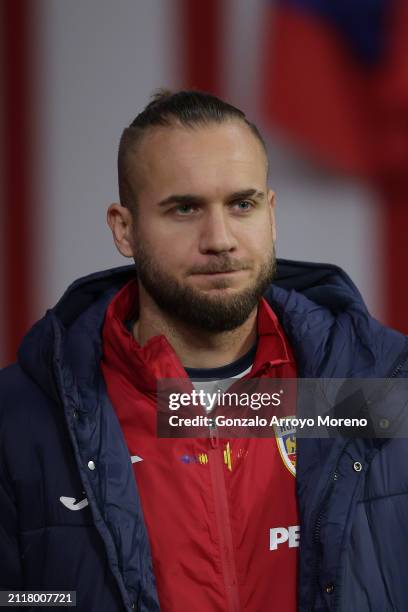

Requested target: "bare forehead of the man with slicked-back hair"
[{"left": 130, "top": 121, "right": 267, "bottom": 199}]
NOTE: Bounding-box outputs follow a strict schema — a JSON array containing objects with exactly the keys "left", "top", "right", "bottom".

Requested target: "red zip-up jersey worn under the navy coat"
[{"left": 102, "top": 281, "right": 299, "bottom": 612}]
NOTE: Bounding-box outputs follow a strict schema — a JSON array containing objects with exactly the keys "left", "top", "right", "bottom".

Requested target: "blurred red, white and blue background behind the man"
[{"left": 0, "top": 0, "right": 408, "bottom": 365}]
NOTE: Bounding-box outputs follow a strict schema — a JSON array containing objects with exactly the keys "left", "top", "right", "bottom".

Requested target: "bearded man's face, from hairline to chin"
[{"left": 126, "top": 121, "right": 275, "bottom": 332}]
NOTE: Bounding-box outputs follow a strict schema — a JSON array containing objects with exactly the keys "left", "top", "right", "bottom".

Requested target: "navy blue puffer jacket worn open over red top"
[{"left": 0, "top": 260, "right": 408, "bottom": 612}]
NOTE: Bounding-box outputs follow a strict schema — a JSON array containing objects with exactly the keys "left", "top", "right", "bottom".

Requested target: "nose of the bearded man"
[{"left": 199, "top": 207, "right": 238, "bottom": 254}]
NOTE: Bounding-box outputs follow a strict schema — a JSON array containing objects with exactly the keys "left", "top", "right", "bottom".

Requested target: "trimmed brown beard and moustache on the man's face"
[{"left": 135, "top": 242, "right": 276, "bottom": 333}]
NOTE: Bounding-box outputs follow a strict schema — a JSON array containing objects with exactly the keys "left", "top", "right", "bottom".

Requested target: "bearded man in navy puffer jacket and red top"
[{"left": 0, "top": 92, "right": 408, "bottom": 612}]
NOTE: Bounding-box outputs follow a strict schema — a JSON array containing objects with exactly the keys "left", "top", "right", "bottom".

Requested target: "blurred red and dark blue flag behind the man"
[{"left": 263, "top": 0, "right": 408, "bottom": 332}]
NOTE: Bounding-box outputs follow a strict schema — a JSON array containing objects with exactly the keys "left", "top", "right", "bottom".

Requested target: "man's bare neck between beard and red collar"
[{"left": 133, "top": 286, "right": 257, "bottom": 368}]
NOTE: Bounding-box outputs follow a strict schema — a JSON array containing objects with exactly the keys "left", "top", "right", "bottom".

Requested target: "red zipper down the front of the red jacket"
[{"left": 208, "top": 427, "right": 241, "bottom": 612}]
